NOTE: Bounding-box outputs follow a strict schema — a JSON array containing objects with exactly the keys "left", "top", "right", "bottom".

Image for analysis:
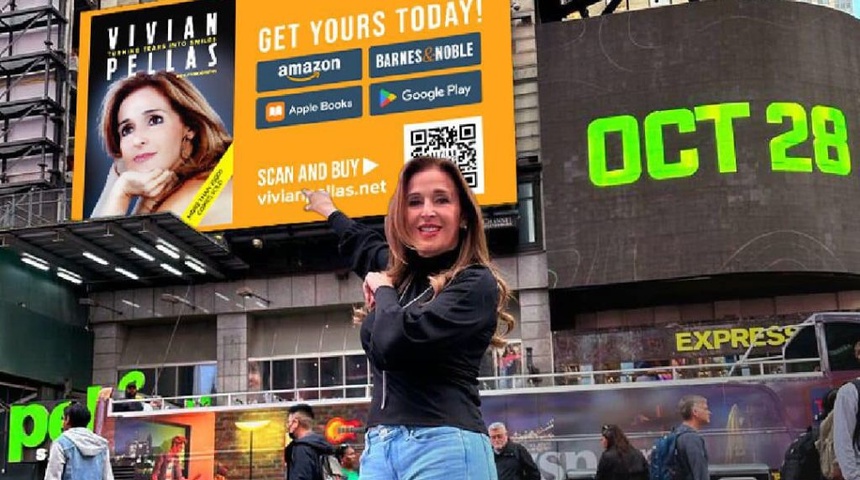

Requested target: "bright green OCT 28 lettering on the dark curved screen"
[{"left": 588, "top": 102, "right": 851, "bottom": 187}]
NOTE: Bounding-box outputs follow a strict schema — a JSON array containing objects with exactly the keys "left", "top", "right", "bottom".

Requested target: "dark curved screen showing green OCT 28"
[{"left": 537, "top": 0, "right": 860, "bottom": 288}]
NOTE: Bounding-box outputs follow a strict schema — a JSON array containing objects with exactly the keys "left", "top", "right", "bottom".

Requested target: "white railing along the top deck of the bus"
[{"left": 110, "top": 358, "right": 821, "bottom": 416}]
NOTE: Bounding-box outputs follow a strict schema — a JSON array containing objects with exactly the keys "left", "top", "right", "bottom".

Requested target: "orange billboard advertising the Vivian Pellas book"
[{"left": 72, "top": 0, "right": 516, "bottom": 230}]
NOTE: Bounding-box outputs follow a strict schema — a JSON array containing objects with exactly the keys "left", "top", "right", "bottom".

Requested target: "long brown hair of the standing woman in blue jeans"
[{"left": 353, "top": 157, "right": 514, "bottom": 347}]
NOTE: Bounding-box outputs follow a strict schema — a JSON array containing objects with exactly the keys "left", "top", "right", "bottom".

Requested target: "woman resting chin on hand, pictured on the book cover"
[{"left": 92, "top": 71, "right": 233, "bottom": 225}]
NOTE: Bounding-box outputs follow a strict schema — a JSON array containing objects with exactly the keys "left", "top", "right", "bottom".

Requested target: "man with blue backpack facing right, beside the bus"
[{"left": 650, "top": 395, "right": 711, "bottom": 480}]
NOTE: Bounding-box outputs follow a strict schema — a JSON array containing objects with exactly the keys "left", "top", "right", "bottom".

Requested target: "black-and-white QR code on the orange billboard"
[{"left": 403, "top": 117, "right": 484, "bottom": 194}]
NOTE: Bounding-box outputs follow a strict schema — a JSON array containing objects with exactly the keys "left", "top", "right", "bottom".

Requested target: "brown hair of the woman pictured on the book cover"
[{"left": 99, "top": 71, "right": 233, "bottom": 209}]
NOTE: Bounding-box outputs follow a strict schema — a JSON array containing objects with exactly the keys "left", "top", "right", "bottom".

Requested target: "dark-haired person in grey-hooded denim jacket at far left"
[{"left": 45, "top": 402, "right": 113, "bottom": 480}]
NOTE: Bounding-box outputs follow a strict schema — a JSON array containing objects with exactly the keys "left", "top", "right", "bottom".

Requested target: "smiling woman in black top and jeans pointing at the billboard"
[{"left": 304, "top": 158, "right": 513, "bottom": 480}]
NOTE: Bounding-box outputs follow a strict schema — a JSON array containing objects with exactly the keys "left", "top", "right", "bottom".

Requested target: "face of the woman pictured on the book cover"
[{"left": 117, "top": 87, "right": 192, "bottom": 172}]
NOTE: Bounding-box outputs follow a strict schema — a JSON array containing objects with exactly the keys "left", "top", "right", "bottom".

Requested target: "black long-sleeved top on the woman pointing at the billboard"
[{"left": 329, "top": 212, "right": 499, "bottom": 434}]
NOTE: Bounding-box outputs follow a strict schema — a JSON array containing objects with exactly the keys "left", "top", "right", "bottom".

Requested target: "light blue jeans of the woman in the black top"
[{"left": 360, "top": 425, "right": 498, "bottom": 480}]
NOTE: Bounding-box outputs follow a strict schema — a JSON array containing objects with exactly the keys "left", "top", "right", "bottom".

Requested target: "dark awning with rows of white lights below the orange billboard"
[{"left": 0, "top": 213, "right": 248, "bottom": 289}]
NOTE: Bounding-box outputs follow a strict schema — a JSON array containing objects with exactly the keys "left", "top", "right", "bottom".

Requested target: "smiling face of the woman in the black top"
[{"left": 406, "top": 168, "right": 462, "bottom": 257}]
